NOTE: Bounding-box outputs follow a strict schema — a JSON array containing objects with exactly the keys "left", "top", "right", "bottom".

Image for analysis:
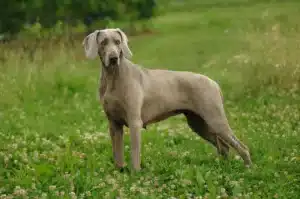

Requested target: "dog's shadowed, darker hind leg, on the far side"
[{"left": 184, "top": 112, "right": 229, "bottom": 158}]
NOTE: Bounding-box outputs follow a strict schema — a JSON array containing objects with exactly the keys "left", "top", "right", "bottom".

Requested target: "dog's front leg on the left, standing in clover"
[{"left": 109, "top": 121, "right": 125, "bottom": 168}]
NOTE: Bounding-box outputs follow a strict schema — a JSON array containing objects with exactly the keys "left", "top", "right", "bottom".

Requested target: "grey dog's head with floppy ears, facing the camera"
[{"left": 82, "top": 28, "right": 132, "bottom": 67}]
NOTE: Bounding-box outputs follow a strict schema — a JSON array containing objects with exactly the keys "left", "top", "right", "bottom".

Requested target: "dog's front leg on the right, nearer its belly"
[{"left": 128, "top": 119, "right": 143, "bottom": 171}]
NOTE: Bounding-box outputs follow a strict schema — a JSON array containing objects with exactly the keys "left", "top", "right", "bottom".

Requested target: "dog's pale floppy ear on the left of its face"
[{"left": 82, "top": 30, "right": 100, "bottom": 59}]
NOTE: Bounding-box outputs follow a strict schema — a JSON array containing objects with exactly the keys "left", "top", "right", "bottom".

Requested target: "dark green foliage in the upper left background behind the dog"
[{"left": 0, "top": 0, "right": 156, "bottom": 37}]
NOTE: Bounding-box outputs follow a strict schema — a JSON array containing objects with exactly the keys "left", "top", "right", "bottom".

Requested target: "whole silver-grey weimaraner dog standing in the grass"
[{"left": 83, "top": 28, "right": 252, "bottom": 171}]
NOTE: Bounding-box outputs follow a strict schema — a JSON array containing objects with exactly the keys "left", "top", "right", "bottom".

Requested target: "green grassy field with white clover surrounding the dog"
[{"left": 0, "top": 1, "right": 300, "bottom": 199}]
